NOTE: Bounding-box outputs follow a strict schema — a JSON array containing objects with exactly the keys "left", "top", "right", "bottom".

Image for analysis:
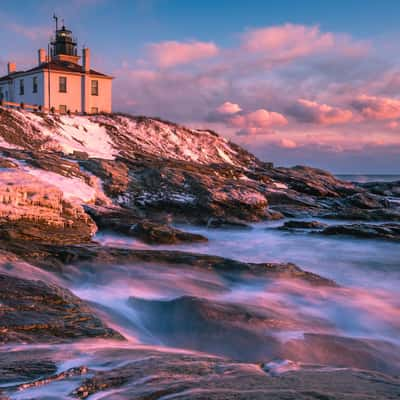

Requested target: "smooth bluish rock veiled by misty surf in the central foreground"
[{"left": 129, "top": 296, "right": 332, "bottom": 361}]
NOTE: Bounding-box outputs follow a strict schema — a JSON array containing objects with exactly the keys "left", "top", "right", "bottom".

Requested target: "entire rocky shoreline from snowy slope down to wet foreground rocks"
[{"left": 0, "top": 108, "right": 400, "bottom": 400}]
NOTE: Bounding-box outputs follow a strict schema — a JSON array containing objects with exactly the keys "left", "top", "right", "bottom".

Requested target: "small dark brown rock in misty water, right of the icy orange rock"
[{"left": 129, "top": 221, "right": 207, "bottom": 244}]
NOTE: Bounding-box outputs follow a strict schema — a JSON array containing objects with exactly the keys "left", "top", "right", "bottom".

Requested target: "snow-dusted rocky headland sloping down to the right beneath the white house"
[{"left": 0, "top": 109, "right": 400, "bottom": 244}]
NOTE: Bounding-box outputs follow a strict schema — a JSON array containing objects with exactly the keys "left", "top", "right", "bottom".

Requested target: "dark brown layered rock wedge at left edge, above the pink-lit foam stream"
[{"left": 0, "top": 274, "right": 122, "bottom": 344}]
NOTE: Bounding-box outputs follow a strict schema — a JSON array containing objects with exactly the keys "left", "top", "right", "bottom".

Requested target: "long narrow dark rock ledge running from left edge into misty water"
[{"left": 0, "top": 240, "right": 337, "bottom": 287}]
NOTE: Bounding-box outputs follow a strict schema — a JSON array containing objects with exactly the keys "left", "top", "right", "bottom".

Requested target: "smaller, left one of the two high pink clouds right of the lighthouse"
[{"left": 148, "top": 41, "right": 219, "bottom": 68}]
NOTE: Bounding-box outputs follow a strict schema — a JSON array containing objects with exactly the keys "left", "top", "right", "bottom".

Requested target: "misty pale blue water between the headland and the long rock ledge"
[{"left": 95, "top": 221, "right": 400, "bottom": 291}]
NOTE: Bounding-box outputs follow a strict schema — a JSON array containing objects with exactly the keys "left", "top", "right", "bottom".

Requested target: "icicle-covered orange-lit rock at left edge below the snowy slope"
[{"left": 0, "top": 170, "right": 97, "bottom": 244}]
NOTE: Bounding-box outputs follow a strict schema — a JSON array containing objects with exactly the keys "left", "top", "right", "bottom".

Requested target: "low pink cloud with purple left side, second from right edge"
[{"left": 290, "top": 99, "right": 353, "bottom": 125}]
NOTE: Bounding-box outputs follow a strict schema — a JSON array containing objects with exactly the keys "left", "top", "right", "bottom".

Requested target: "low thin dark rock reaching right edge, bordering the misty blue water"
[{"left": 320, "top": 223, "right": 400, "bottom": 241}]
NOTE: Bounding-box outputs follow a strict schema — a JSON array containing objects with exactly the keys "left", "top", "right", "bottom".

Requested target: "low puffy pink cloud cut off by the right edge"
[{"left": 352, "top": 95, "right": 400, "bottom": 120}]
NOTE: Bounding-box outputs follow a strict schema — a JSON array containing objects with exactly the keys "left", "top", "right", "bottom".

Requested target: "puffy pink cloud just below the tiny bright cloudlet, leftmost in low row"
[{"left": 229, "top": 108, "right": 288, "bottom": 135}]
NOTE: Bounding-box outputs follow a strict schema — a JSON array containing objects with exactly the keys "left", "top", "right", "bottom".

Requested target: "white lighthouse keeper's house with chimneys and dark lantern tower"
[{"left": 0, "top": 23, "right": 113, "bottom": 114}]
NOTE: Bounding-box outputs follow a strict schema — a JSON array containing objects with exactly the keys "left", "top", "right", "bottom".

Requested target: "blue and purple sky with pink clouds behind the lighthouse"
[{"left": 0, "top": 0, "right": 400, "bottom": 174}]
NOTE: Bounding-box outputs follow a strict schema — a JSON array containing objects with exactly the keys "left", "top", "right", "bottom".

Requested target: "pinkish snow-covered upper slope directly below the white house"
[{"left": 0, "top": 110, "right": 245, "bottom": 167}]
